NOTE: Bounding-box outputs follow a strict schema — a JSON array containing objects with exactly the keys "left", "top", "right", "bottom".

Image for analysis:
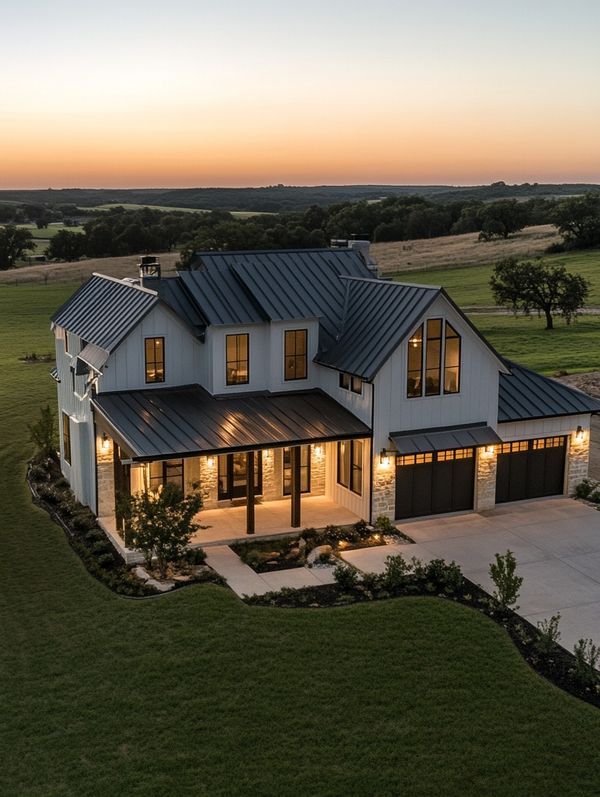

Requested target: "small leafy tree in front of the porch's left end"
[{"left": 123, "top": 484, "right": 202, "bottom": 578}]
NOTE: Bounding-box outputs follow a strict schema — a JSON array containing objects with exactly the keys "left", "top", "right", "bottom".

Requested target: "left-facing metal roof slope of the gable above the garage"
[{"left": 315, "top": 279, "right": 441, "bottom": 381}]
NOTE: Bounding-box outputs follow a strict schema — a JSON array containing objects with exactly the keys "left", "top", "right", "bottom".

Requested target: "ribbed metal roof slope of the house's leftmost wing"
[{"left": 52, "top": 274, "right": 158, "bottom": 352}]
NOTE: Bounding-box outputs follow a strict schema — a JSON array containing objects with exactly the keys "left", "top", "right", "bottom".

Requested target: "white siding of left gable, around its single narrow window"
[{"left": 98, "top": 305, "right": 208, "bottom": 393}]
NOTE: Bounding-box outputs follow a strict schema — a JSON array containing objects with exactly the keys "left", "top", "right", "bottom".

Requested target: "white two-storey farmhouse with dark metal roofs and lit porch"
[{"left": 52, "top": 242, "right": 600, "bottom": 556}]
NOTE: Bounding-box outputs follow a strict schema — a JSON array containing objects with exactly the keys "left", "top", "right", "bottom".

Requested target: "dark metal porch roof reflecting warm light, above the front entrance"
[{"left": 93, "top": 385, "right": 371, "bottom": 461}]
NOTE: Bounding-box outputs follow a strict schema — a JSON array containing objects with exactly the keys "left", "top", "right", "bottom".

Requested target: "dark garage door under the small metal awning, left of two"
[{"left": 396, "top": 448, "right": 475, "bottom": 518}]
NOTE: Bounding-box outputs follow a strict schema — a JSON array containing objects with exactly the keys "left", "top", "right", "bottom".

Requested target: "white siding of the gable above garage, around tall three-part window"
[{"left": 373, "top": 296, "right": 502, "bottom": 451}]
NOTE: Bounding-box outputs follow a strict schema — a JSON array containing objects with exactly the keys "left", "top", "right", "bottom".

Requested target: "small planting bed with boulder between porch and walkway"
[{"left": 229, "top": 517, "right": 413, "bottom": 573}]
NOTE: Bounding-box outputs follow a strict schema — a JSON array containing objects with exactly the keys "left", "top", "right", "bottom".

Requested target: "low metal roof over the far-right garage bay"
[{"left": 498, "top": 360, "right": 600, "bottom": 423}]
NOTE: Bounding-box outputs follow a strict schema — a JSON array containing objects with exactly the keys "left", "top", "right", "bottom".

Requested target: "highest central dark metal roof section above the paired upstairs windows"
[{"left": 180, "top": 249, "right": 371, "bottom": 347}]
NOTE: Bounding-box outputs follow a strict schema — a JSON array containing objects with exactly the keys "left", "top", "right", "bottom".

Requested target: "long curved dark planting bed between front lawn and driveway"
[{"left": 245, "top": 556, "right": 600, "bottom": 708}]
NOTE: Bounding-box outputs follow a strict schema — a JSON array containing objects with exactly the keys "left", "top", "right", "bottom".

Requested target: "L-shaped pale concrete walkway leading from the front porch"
[{"left": 206, "top": 545, "right": 334, "bottom": 597}]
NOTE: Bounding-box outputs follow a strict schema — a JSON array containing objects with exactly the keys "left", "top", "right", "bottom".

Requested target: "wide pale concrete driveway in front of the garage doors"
[{"left": 344, "top": 497, "right": 600, "bottom": 650}]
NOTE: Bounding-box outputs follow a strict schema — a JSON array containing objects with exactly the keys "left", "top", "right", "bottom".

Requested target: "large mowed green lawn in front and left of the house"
[{"left": 0, "top": 283, "right": 600, "bottom": 797}]
